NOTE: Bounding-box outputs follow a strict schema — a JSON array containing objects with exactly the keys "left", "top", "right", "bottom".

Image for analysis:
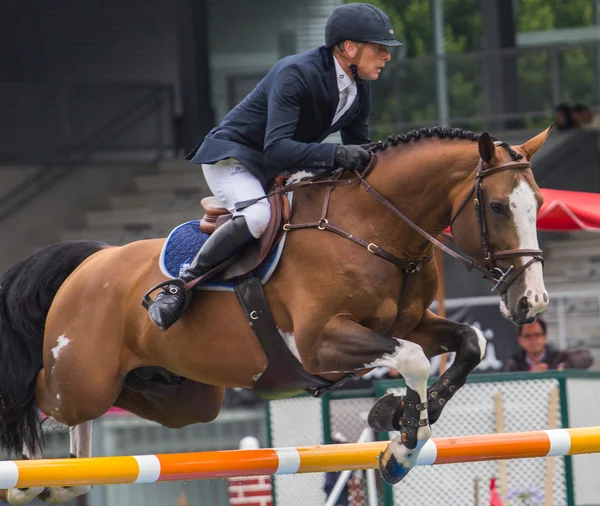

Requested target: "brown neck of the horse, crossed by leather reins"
[{"left": 292, "top": 140, "right": 477, "bottom": 259}]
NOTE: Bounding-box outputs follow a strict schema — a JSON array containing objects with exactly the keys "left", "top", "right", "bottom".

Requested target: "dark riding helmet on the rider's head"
[{"left": 325, "top": 3, "right": 402, "bottom": 47}]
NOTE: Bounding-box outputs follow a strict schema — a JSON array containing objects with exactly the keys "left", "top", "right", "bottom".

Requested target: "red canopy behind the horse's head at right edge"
[{"left": 537, "top": 188, "right": 600, "bottom": 232}]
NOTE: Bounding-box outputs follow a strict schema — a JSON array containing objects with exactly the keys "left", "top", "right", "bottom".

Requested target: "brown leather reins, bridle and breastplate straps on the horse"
[{"left": 235, "top": 143, "right": 544, "bottom": 295}]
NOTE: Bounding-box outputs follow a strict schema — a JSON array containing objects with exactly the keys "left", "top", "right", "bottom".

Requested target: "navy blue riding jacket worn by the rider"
[{"left": 188, "top": 46, "right": 371, "bottom": 183}]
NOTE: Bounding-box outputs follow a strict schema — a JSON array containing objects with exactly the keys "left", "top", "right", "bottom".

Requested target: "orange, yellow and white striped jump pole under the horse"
[{"left": 0, "top": 427, "right": 600, "bottom": 489}]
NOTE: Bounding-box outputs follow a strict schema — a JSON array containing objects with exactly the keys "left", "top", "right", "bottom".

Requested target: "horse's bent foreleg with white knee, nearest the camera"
[{"left": 300, "top": 317, "right": 431, "bottom": 483}]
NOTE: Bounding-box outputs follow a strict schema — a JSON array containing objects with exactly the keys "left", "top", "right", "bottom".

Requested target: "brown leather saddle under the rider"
[{"left": 185, "top": 176, "right": 291, "bottom": 288}]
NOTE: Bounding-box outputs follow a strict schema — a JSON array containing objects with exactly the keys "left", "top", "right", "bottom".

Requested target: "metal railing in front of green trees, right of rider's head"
[{"left": 372, "top": 39, "right": 600, "bottom": 138}]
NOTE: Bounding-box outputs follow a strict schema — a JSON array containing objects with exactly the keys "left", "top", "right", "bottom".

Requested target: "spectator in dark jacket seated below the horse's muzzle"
[{"left": 504, "top": 317, "right": 594, "bottom": 372}]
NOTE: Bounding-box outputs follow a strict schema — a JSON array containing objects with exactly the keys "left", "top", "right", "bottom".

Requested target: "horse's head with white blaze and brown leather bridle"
[{"left": 451, "top": 128, "right": 550, "bottom": 325}]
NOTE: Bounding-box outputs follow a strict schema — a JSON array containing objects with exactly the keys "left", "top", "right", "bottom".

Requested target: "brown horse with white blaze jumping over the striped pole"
[{"left": 0, "top": 128, "right": 549, "bottom": 504}]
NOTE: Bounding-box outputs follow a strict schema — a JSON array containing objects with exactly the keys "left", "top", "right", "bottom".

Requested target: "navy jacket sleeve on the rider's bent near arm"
[{"left": 264, "top": 67, "right": 337, "bottom": 169}]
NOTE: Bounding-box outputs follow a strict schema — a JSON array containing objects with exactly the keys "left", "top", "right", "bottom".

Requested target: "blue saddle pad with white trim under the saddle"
[{"left": 159, "top": 220, "right": 287, "bottom": 291}]
